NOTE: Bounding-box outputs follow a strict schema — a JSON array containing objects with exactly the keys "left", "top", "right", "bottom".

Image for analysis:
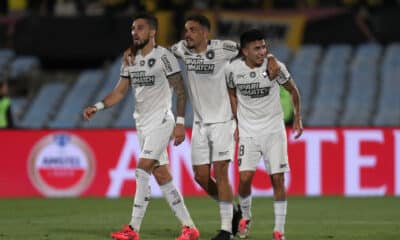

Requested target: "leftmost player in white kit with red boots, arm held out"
[{"left": 83, "top": 13, "right": 200, "bottom": 240}]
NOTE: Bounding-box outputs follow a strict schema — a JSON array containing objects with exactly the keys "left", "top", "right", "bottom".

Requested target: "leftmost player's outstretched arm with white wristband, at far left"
[{"left": 83, "top": 77, "right": 129, "bottom": 120}]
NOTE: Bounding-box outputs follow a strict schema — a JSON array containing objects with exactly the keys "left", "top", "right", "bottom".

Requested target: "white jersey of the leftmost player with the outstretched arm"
[{"left": 121, "top": 46, "right": 180, "bottom": 131}]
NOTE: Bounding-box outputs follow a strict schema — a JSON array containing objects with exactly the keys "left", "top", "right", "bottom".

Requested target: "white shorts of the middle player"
[{"left": 191, "top": 120, "right": 236, "bottom": 166}]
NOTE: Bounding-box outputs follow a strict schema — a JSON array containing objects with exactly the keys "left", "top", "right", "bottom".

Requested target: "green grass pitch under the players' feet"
[{"left": 0, "top": 197, "right": 400, "bottom": 240}]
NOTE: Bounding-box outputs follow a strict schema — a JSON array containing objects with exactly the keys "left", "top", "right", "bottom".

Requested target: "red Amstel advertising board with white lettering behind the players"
[{"left": 0, "top": 128, "right": 400, "bottom": 197}]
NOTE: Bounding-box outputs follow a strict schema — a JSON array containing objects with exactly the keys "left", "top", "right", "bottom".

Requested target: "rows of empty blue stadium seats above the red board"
[{"left": 7, "top": 43, "right": 400, "bottom": 128}]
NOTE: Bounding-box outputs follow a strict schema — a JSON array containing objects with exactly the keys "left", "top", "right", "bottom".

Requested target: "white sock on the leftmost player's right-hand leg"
[{"left": 160, "top": 181, "right": 195, "bottom": 228}]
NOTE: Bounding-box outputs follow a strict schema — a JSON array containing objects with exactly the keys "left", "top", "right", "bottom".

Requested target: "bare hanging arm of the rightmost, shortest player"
[{"left": 283, "top": 77, "right": 303, "bottom": 139}]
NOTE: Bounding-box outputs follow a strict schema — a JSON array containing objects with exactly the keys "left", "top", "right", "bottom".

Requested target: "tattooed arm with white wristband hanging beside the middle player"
[{"left": 168, "top": 72, "right": 186, "bottom": 145}]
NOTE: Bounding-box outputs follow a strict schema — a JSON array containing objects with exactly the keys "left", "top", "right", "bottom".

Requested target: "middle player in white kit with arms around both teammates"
[{"left": 125, "top": 15, "right": 278, "bottom": 240}]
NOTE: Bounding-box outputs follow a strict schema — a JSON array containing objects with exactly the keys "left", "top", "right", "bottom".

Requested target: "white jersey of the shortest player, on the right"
[{"left": 225, "top": 59, "right": 290, "bottom": 137}]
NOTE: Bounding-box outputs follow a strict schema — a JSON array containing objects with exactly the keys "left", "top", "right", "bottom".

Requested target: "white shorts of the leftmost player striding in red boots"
[{"left": 137, "top": 118, "right": 175, "bottom": 165}]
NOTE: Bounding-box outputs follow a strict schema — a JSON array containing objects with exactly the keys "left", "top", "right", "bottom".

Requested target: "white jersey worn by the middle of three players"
[{"left": 171, "top": 40, "right": 238, "bottom": 123}]
